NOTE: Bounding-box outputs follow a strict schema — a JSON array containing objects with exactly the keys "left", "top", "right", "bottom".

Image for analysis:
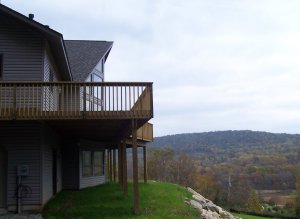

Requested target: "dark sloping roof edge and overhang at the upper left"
[{"left": 0, "top": 3, "right": 72, "bottom": 80}]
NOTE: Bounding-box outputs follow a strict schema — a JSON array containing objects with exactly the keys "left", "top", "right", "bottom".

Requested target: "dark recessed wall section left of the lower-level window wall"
[{"left": 61, "top": 143, "right": 79, "bottom": 190}]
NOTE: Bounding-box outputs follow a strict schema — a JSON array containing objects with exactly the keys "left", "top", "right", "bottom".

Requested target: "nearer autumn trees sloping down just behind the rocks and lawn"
[{"left": 148, "top": 148, "right": 300, "bottom": 215}]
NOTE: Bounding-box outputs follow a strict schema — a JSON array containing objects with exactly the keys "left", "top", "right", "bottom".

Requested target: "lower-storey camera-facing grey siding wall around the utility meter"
[{"left": 0, "top": 122, "right": 41, "bottom": 209}]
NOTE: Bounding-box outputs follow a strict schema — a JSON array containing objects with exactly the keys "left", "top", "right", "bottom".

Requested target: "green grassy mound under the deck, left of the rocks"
[{"left": 43, "top": 181, "right": 199, "bottom": 219}]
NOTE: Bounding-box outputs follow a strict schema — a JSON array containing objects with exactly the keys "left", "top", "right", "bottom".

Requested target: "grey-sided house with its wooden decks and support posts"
[{"left": 0, "top": 4, "right": 153, "bottom": 216}]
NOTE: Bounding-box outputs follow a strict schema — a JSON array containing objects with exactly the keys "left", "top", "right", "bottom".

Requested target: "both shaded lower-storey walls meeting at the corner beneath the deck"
[{"left": 0, "top": 122, "right": 62, "bottom": 211}]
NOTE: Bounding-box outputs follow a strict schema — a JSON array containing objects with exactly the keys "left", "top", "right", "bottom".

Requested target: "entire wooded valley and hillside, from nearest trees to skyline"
[{"left": 148, "top": 131, "right": 300, "bottom": 216}]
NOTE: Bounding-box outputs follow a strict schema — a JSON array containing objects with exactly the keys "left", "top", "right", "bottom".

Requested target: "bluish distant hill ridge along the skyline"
[{"left": 149, "top": 130, "right": 300, "bottom": 153}]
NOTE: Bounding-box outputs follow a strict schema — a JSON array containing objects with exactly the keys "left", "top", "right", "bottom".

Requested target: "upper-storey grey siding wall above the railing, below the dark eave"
[{"left": 0, "top": 15, "right": 44, "bottom": 81}]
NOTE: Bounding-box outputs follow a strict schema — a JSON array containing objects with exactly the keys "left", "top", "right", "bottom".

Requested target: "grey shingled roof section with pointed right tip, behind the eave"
[{"left": 64, "top": 40, "right": 113, "bottom": 81}]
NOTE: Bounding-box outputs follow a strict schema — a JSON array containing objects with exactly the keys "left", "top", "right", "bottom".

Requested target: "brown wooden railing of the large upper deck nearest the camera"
[{"left": 0, "top": 82, "right": 153, "bottom": 120}]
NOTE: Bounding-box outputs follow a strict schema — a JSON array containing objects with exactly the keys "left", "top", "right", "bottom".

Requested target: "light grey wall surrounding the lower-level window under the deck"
[{"left": 79, "top": 142, "right": 106, "bottom": 189}]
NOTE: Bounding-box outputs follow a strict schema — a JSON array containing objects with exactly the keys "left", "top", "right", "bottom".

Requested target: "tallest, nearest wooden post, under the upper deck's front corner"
[{"left": 132, "top": 120, "right": 140, "bottom": 215}]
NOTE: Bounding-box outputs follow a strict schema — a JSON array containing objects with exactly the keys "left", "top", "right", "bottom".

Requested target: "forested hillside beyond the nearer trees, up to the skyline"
[{"left": 148, "top": 131, "right": 300, "bottom": 189}]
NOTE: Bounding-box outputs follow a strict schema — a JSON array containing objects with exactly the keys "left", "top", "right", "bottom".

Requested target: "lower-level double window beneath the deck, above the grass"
[{"left": 82, "top": 151, "right": 104, "bottom": 177}]
